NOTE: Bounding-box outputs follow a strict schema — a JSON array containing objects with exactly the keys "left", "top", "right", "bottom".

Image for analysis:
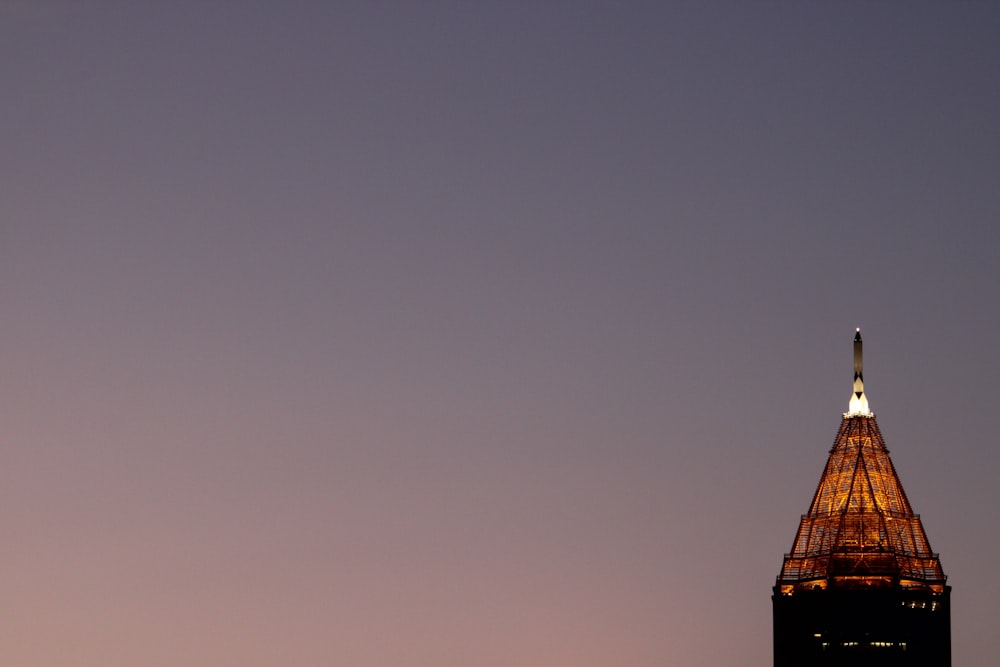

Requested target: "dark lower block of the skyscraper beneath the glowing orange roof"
[{"left": 771, "top": 587, "right": 951, "bottom": 667}]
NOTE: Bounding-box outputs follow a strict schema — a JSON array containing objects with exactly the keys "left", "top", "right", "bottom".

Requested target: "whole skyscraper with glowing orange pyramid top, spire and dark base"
[{"left": 771, "top": 329, "right": 951, "bottom": 667}]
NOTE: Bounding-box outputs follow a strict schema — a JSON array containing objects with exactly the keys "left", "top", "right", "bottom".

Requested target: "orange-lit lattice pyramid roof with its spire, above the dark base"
[{"left": 777, "top": 329, "right": 945, "bottom": 594}]
